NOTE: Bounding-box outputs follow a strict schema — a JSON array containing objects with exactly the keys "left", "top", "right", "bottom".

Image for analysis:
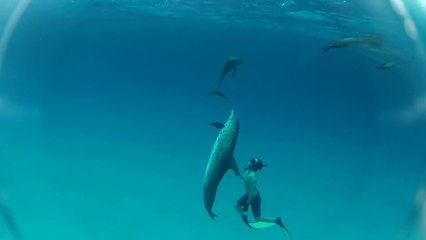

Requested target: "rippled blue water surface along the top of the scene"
[{"left": 24, "top": 0, "right": 400, "bottom": 37}]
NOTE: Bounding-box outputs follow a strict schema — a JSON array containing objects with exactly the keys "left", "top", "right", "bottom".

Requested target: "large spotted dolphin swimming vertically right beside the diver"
[{"left": 203, "top": 110, "right": 240, "bottom": 219}]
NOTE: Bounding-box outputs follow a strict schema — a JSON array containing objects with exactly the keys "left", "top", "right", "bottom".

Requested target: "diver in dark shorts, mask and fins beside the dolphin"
[{"left": 235, "top": 158, "right": 292, "bottom": 238}]
